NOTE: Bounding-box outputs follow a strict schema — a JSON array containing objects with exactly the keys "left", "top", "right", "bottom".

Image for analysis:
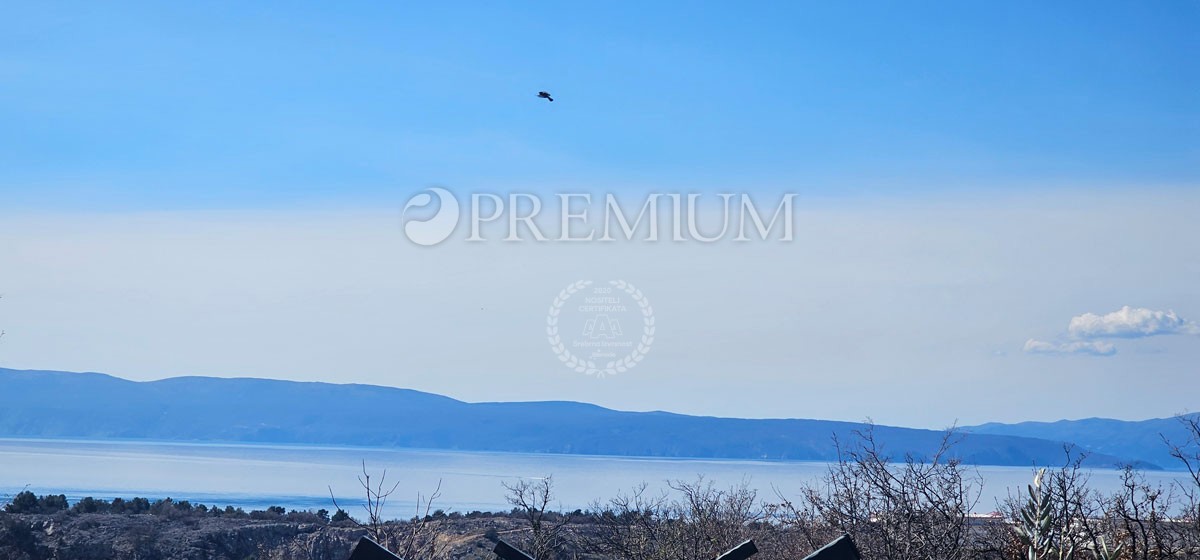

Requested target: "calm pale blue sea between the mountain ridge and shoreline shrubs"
[{"left": 0, "top": 439, "right": 1184, "bottom": 517}]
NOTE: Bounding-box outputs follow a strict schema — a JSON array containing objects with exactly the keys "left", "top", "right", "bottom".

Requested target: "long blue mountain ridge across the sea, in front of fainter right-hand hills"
[{"left": 0, "top": 368, "right": 1159, "bottom": 469}]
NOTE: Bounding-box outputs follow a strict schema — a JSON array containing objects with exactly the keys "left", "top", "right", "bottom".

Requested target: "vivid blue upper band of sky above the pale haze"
[{"left": 0, "top": 1, "right": 1200, "bottom": 209}]
